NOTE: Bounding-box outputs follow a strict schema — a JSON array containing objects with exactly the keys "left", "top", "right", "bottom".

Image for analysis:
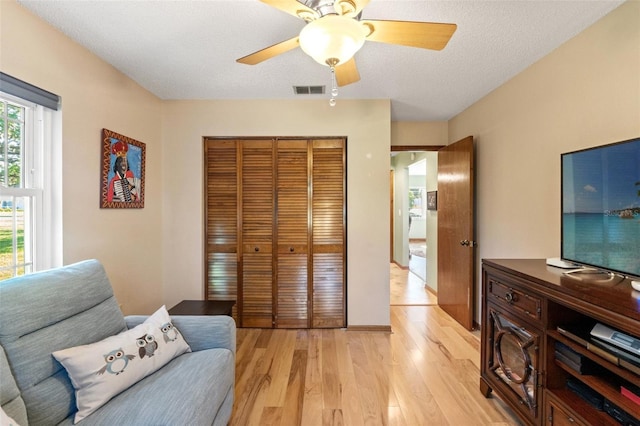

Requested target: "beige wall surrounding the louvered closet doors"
[{"left": 162, "top": 99, "right": 390, "bottom": 326}]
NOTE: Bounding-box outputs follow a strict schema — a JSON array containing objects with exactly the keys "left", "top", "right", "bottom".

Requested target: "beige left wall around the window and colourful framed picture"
[{"left": 0, "top": 0, "right": 163, "bottom": 312}]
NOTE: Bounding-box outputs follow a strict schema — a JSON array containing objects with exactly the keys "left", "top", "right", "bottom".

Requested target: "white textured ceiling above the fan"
[{"left": 18, "top": 0, "right": 623, "bottom": 121}]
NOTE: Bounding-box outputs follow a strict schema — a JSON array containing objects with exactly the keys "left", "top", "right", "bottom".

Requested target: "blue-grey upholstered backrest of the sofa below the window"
[{"left": 0, "top": 260, "right": 126, "bottom": 424}]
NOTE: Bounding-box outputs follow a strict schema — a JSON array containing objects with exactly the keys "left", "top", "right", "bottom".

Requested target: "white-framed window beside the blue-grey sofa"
[{"left": 0, "top": 92, "right": 61, "bottom": 280}]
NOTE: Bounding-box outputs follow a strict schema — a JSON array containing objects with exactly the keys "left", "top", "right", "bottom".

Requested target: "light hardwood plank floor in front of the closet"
[{"left": 230, "top": 306, "right": 518, "bottom": 426}]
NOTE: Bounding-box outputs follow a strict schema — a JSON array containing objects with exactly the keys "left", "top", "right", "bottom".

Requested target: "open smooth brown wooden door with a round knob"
[{"left": 438, "top": 136, "right": 475, "bottom": 330}]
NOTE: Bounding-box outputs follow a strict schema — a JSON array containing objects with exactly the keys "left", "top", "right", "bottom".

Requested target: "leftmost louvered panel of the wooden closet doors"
[{"left": 205, "top": 140, "right": 238, "bottom": 309}]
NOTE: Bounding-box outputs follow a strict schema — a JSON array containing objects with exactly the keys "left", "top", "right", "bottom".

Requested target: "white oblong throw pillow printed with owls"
[{"left": 53, "top": 306, "right": 191, "bottom": 423}]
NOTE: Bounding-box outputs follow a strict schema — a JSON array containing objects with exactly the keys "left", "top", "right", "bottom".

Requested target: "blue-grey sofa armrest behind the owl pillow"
[{"left": 125, "top": 315, "right": 236, "bottom": 356}]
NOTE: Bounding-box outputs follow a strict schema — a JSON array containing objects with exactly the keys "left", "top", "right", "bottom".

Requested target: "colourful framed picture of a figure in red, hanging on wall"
[{"left": 100, "top": 129, "right": 145, "bottom": 209}]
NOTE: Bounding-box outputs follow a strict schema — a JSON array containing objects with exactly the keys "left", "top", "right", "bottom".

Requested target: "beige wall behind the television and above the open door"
[{"left": 449, "top": 1, "right": 640, "bottom": 320}]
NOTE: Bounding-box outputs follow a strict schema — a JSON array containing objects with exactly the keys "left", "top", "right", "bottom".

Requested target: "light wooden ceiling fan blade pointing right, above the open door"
[{"left": 361, "top": 19, "right": 458, "bottom": 50}]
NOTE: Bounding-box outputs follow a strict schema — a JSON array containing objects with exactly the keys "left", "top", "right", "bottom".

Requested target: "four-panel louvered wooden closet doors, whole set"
[{"left": 205, "top": 139, "right": 346, "bottom": 328}]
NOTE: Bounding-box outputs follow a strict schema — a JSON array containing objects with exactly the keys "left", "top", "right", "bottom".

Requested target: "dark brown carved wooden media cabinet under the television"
[{"left": 480, "top": 259, "right": 640, "bottom": 425}]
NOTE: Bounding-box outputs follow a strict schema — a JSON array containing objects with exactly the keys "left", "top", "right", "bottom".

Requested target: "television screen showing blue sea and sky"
[{"left": 562, "top": 139, "right": 640, "bottom": 277}]
